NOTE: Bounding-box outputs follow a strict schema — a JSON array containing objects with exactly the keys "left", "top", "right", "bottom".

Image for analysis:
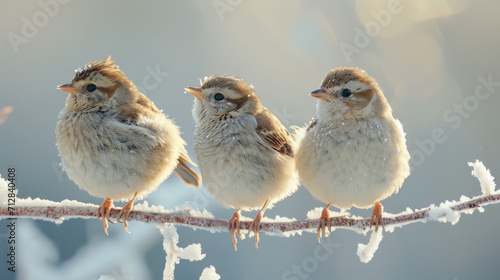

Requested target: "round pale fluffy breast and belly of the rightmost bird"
[{"left": 296, "top": 118, "right": 410, "bottom": 209}]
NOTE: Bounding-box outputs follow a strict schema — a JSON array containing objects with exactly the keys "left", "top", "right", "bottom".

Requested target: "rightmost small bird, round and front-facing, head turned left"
[{"left": 296, "top": 67, "right": 410, "bottom": 241}]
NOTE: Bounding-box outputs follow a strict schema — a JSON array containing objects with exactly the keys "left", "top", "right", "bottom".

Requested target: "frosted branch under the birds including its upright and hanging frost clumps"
[{"left": 0, "top": 161, "right": 500, "bottom": 262}]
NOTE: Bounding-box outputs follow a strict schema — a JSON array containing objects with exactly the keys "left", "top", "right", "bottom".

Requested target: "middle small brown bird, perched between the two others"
[{"left": 185, "top": 75, "right": 298, "bottom": 250}]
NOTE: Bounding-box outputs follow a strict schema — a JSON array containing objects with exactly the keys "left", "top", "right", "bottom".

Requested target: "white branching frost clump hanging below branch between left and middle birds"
[{"left": 156, "top": 225, "right": 205, "bottom": 280}]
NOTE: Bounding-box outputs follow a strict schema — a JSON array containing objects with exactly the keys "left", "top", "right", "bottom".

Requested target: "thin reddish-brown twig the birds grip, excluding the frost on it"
[{"left": 0, "top": 192, "right": 500, "bottom": 235}]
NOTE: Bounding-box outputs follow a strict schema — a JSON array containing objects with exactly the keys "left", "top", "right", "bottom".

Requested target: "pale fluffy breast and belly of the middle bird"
[{"left": 194, "top": 116, "right": 298, "bottom": 209}]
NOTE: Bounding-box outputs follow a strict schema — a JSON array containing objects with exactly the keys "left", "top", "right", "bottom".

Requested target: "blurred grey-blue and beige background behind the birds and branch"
[{"left": 0, "top": 0, "right": 500, "bottom": 279}]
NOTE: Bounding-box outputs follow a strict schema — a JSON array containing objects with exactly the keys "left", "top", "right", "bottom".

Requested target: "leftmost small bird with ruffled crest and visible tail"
[{"left": 56, "top": 56, "right": 201, "bottom": 234}]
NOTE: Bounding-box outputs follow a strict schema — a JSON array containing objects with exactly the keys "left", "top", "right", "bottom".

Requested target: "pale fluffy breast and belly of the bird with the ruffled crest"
[{"left": 56, "top": 110, "right": 184, "bottom": 200}]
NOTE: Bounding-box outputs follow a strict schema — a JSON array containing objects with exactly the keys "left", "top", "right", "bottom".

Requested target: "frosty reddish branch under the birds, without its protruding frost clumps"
[{"left": 0, "top": 192, "right": 500, "bottom": 236}]
